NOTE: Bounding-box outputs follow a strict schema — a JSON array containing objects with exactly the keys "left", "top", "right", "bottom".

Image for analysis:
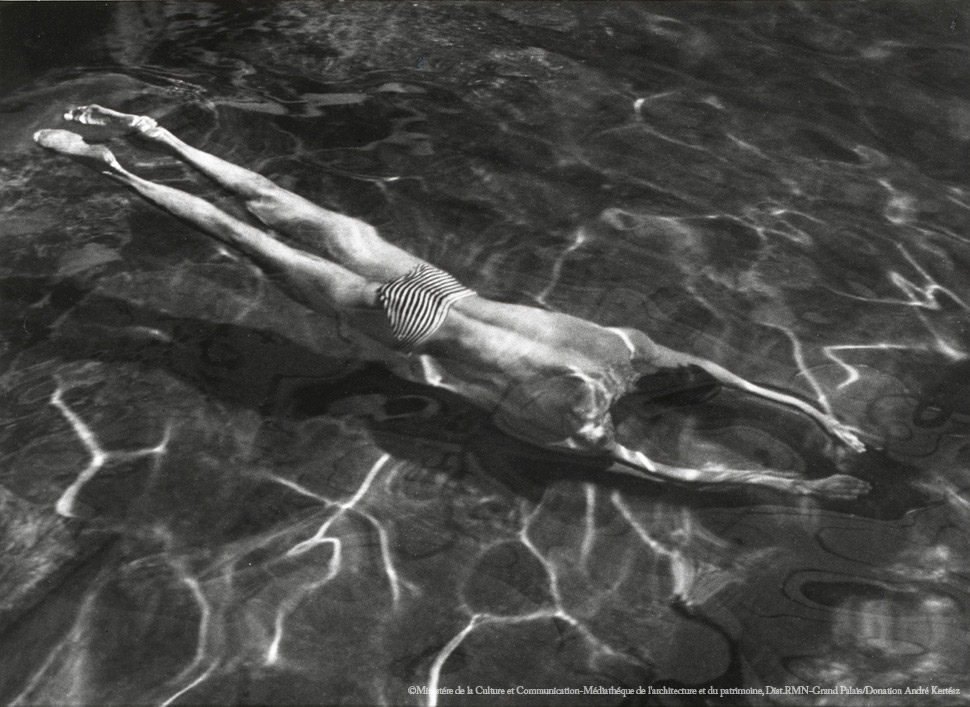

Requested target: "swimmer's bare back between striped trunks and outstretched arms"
[{"left": 390, "top": 297, "right": 652, "bottom": 449}]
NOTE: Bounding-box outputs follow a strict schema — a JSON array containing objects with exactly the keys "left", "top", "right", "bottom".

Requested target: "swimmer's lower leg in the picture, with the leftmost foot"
[{"left": 34, "top": 130, "right": 392, "bottom": 343}]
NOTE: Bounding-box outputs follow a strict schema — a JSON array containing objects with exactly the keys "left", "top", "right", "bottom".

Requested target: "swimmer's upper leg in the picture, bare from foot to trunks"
[{"left": 64, "top": 105, "right": 424, "bottom": 282}]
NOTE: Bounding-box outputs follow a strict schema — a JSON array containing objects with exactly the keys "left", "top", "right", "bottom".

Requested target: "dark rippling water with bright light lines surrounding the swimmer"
[{"left": 0, "top": 2, "right": 970, "bottom": 705}]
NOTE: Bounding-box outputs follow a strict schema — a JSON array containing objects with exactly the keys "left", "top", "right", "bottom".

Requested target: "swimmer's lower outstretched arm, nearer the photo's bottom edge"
[{"left": 604, "top": 443, "right": 870, "bottom": 500}]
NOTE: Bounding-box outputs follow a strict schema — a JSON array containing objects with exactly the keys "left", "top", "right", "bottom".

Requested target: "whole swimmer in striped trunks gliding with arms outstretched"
[{"left": 34, "top": 105, "right": 869, "bottom": 500}]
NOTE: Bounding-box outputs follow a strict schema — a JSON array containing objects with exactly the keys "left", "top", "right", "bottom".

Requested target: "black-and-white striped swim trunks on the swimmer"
[{"left": 377, "top": 263, "right": 475, "bottom": 353}]
